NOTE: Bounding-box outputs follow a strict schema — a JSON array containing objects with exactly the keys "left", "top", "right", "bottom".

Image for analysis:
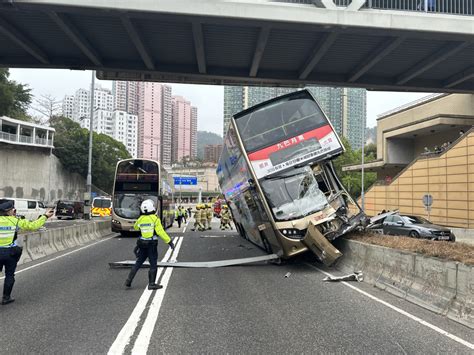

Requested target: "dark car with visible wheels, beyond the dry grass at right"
[{"left": 383, "top": 215, "right": 456, "bottom": 242}]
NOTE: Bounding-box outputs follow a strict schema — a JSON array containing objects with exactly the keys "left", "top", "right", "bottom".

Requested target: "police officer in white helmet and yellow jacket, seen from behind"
[{"left": 125, "top": 200, "right": 174, "bottom": 290}]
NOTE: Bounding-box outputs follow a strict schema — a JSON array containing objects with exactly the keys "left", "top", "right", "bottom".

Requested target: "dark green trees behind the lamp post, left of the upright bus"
[{"left": 50, "top": 117, "right": 130, "bottom": 193}]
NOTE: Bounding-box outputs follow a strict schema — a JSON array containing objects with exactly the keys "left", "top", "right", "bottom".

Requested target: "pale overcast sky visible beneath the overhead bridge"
[{"left": 10, "top": 69, "right": 428, "bottom": 135}]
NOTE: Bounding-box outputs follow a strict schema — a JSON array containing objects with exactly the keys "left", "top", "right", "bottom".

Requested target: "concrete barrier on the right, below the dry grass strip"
[{"left": 335, "top": 239, "right": 474, "bottom": 329}]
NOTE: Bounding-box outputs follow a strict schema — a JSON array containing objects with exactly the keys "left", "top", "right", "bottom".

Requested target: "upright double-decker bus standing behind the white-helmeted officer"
[{"left": 112, "top": 159, "right": 174, "bottom": 235}]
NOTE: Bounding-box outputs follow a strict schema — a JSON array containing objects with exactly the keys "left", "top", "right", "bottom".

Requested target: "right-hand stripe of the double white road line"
[{"left": 132, "top": 238, "right": 183, "bottom": 354}]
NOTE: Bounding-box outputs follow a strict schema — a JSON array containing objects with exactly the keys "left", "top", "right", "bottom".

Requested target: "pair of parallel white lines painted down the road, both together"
[{"left": 108, "top": 237, "right": 183, "bottom": 355}]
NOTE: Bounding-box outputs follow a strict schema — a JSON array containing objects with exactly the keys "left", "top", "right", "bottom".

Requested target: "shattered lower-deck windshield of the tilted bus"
[{"left": 260, "top": 166, "right": 328, "bottom": 221}]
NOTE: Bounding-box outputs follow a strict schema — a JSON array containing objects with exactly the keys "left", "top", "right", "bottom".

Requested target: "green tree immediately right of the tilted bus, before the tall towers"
[{"left": 334, "top": 137, "right": 377, "bottom": 198}]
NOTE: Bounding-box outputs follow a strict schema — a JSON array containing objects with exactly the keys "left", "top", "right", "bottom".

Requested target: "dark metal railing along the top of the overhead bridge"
[{"left": 274, "top": 0, "right": 474, "bottom": 16}]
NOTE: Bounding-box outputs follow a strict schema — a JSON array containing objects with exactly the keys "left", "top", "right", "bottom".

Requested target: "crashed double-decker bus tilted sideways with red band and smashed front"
[{"left": 217, "top": 90, "right": 364, "bottom": 264}]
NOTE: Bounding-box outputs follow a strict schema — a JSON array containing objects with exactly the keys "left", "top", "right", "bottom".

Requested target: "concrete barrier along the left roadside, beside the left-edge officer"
[{"left": 18, "top": 221, "right": 111, "bottom": 264}]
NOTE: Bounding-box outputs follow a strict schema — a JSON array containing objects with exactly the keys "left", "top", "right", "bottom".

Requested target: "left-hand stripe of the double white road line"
[{"left": 108, "top": 238, "right": 181, "bottom": 355}]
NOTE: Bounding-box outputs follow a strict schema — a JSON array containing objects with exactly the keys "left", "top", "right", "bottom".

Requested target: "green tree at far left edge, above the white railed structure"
[{"left": 0, "top": 68, "right": 31, "bottom": 121}]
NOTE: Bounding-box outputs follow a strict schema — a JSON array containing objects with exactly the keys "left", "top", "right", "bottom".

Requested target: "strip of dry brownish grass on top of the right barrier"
[{"left": 346, "top": 233, "right": 474, "bottom": 265}]
